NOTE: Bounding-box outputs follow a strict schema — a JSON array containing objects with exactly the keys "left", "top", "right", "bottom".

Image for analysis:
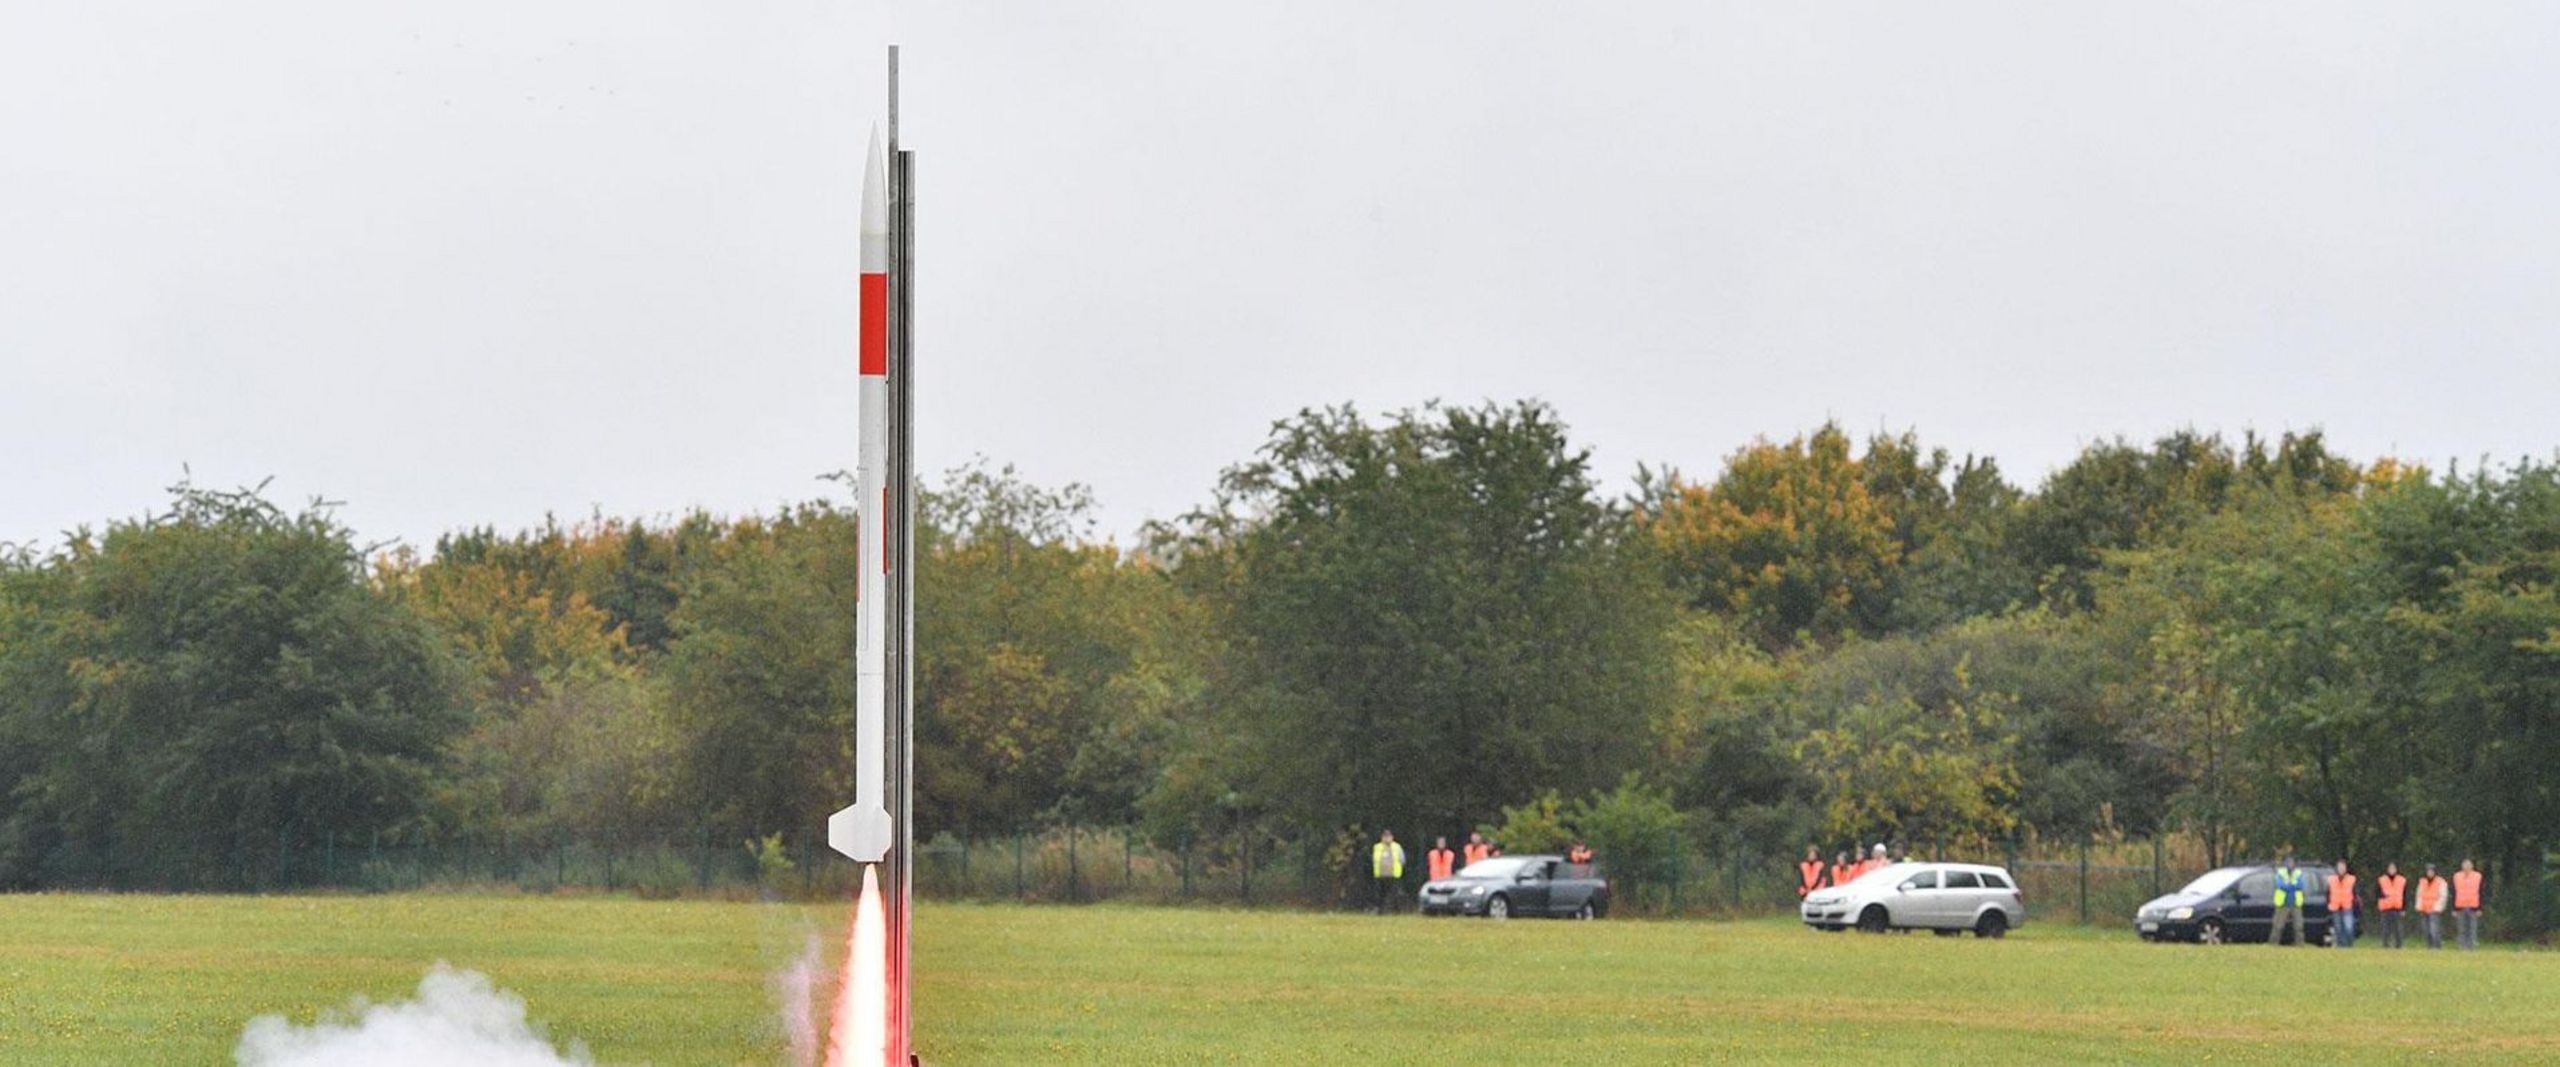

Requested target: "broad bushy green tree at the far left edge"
[{"left": 0, "top": 486, "right": 466, "bottom": 885}]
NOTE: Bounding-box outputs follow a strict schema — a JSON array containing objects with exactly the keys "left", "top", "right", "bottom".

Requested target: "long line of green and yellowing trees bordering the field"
[{"left": 0, "top": 402, "right": 2560, "bottom": 921}]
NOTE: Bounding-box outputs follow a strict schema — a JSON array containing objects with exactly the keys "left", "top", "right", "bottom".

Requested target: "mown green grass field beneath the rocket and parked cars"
[{"left": 0, "top": 896, "right": 2560, "bottom": 1067}]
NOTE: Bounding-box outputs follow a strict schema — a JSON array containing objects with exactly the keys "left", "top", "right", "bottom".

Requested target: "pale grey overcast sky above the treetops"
[{"left": 0, "top": 0, "right": 2560, "bottom": 545}]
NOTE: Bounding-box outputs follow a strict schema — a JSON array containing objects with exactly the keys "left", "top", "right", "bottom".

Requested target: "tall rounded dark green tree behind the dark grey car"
[{"left": 1160, "top": 404, "right": 1672, "bottom": 832}]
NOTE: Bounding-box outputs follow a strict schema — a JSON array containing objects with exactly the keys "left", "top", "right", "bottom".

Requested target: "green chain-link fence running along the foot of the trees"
[{"left": 24, "top": 826, "right": 2560, "bottom": 934}]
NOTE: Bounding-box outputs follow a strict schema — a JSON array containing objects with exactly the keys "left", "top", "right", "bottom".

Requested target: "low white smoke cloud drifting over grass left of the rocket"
[{"left": 233, "top": 962, "right": 594, "bottom": 1067}]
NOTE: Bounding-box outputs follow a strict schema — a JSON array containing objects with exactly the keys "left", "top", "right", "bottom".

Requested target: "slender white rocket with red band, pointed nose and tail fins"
[{"left": 827, "top": 128, "right": 896, "bottom": 862}]
